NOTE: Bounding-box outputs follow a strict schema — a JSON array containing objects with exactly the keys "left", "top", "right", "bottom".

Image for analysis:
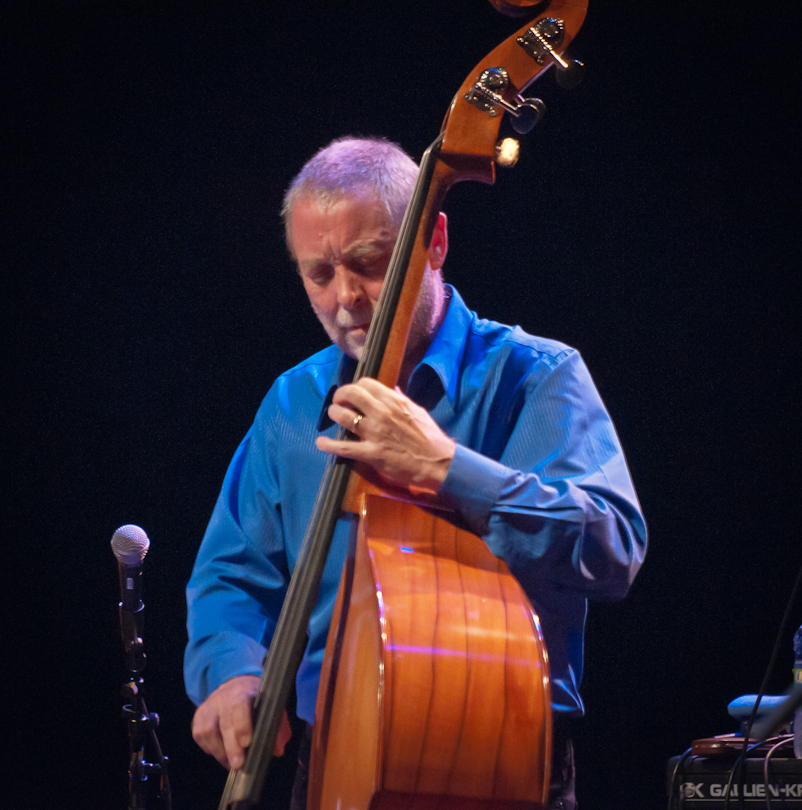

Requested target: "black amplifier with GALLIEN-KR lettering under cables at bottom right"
[{"left": 668, "top": 747, "right": 802, "bottom": 810}]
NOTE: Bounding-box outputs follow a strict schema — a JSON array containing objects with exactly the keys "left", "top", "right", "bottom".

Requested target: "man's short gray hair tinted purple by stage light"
[{"left": 281, "top": 136, "right": 418, "bottom": 252}]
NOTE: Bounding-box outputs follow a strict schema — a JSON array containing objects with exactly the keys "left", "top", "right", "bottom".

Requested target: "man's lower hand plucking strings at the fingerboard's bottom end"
[{"left": 192, "top": 675, "right": 292, "bottom": 769}]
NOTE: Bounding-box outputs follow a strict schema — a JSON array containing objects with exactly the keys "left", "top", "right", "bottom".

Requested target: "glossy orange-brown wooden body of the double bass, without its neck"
[{"left": 310, "top": 495, "right": 551, "bottom": 810}]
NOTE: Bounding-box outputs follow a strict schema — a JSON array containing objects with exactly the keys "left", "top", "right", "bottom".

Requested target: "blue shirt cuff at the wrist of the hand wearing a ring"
[{"left": 438, "top": 444, "right": 510, "bottom": 536}]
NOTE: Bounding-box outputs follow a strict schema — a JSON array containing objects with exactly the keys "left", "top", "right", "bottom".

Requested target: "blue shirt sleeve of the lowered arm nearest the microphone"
[{"left": 184, "top": 414, "right": 289, "bottom": 704}]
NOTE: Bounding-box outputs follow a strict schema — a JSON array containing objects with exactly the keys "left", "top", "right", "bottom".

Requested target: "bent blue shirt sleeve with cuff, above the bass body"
[{"left": 440, "top": 350, "right": 646, "bottom": 598}]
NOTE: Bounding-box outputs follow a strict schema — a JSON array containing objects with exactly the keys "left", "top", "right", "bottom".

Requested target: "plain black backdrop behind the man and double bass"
[{"left": 0, "top": 0, "right": 802, "bottom": 810}]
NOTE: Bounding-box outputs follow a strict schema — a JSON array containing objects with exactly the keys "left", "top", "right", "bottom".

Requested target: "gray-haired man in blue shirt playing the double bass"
[{"left": 185, "top": 138, "right": 646, "bottom": 808}]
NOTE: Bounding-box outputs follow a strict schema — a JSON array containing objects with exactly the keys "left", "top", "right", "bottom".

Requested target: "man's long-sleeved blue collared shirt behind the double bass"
[{"left": 184, "top": 289, "right": 646, "bottom": 723}]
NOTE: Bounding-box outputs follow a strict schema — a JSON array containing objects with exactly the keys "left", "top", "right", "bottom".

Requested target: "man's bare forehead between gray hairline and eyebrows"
[{"left": 290, "top": 191, "right": 396, "bottom": 258}]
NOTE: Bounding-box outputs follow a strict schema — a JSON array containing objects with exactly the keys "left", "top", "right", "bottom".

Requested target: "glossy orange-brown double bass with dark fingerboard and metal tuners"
[{"left": 219, "top": 0, "right": 587, "bottom": 810}]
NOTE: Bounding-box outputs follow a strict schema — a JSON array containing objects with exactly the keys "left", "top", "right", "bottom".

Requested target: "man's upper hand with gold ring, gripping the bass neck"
[{"left": 315, "top": 377, "right": 456, "bottom": 496}]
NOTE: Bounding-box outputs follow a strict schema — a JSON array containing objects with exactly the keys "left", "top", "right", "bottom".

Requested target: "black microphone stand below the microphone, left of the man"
[{"left": 120, "top": 602, "right": 172, "bottom": 810}]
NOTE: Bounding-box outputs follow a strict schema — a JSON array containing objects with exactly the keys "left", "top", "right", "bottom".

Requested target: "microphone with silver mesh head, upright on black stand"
[{"left": 111, "top": 525, "right": 150, "bottom": 673}]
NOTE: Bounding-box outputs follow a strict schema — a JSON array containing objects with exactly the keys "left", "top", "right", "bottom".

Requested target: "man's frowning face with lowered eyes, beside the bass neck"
[{"left": 290, "top": 192, "right": 398, "bottom": 358}]
